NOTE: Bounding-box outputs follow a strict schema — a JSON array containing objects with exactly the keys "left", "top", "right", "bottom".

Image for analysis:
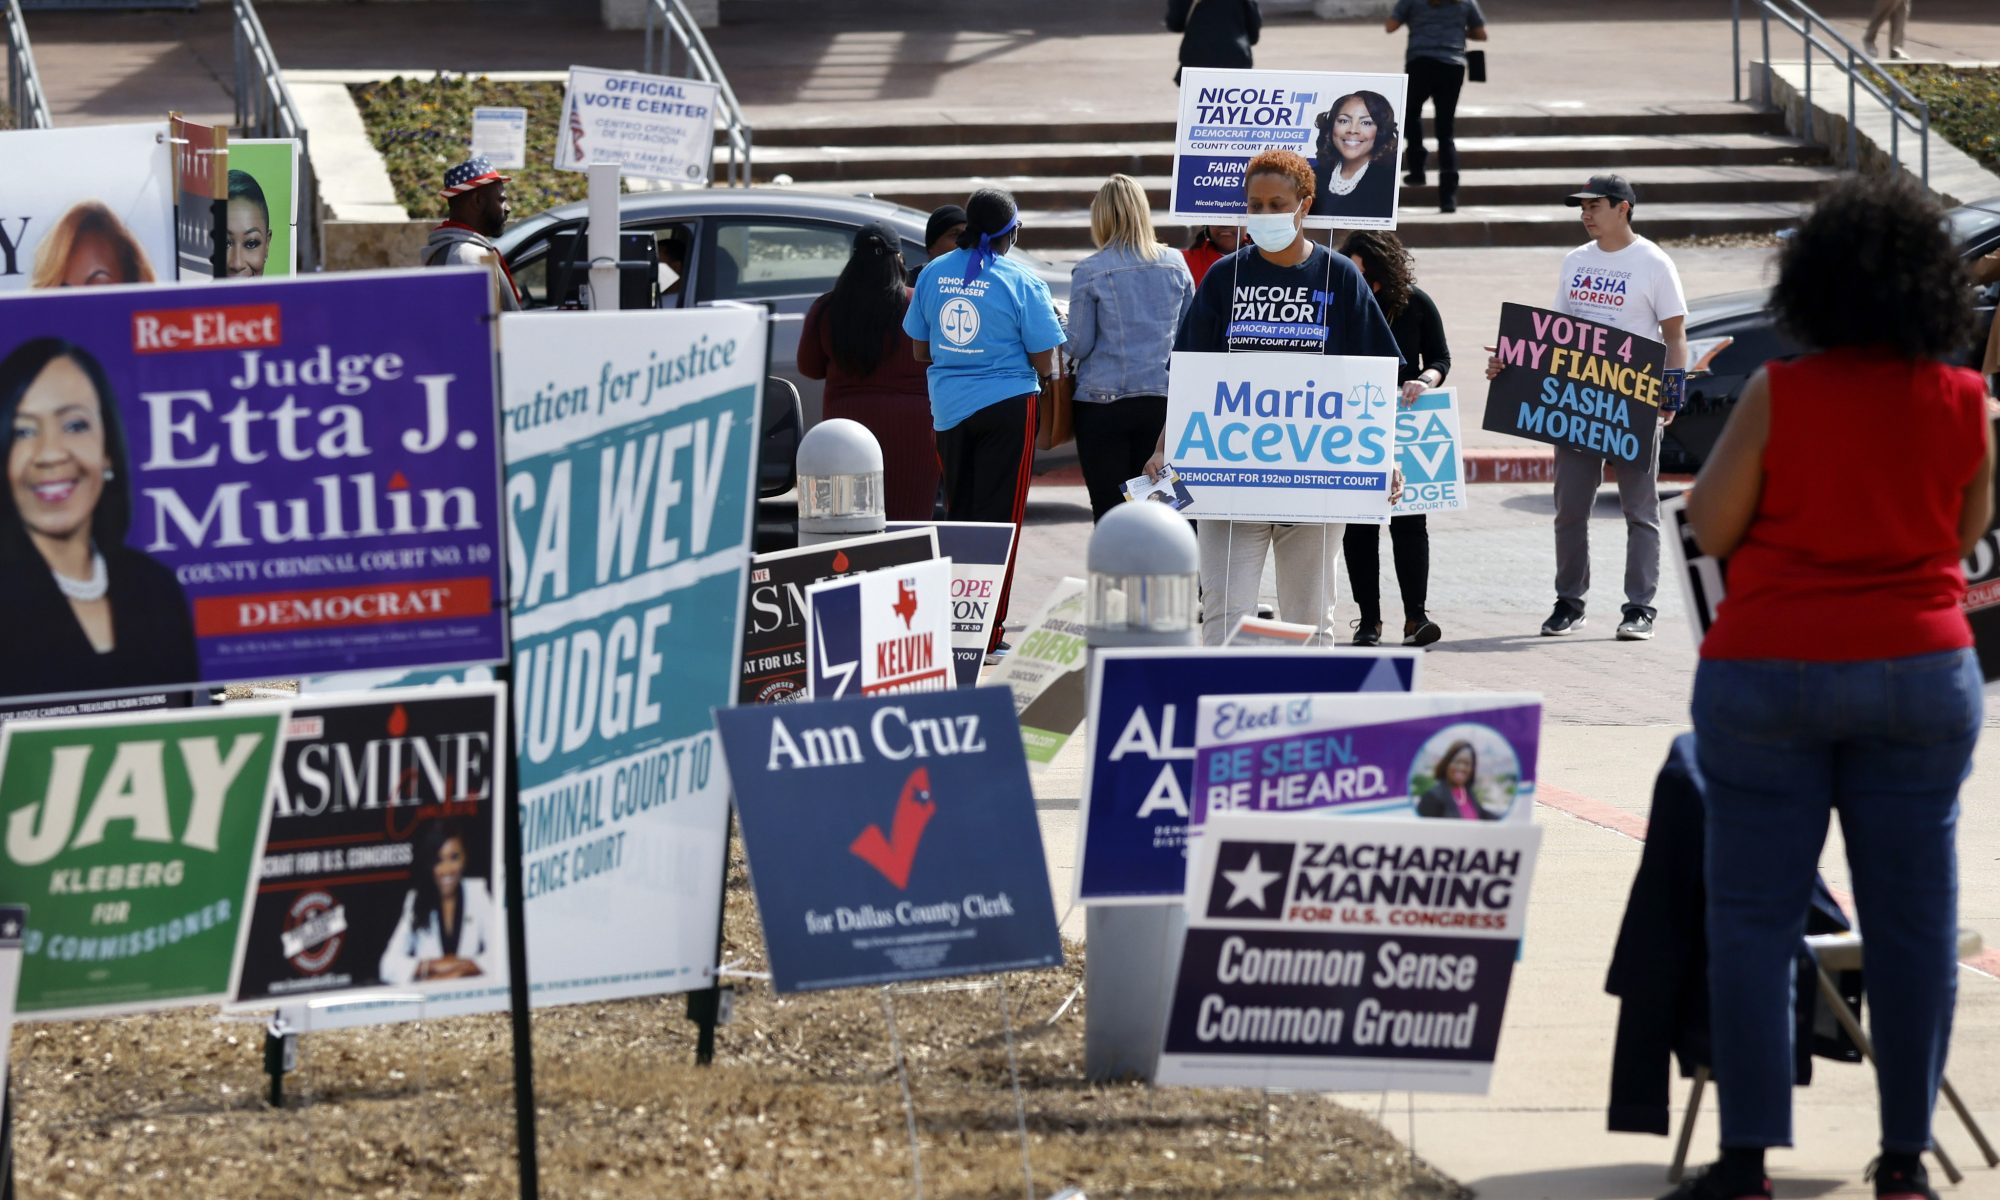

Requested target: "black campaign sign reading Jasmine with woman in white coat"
[{"left": 234, "top": 684, "right": 508, "bottom": 1016}]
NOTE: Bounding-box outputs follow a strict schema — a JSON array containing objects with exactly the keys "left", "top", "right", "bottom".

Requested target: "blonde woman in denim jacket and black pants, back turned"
[{"left": 1068, "top": 174, "right": 1194, "bottom": 520}]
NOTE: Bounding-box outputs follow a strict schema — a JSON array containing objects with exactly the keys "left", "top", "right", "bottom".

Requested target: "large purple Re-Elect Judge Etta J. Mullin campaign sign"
[{"left": 0, "top": 270, "right": 506, "bottom": 700}]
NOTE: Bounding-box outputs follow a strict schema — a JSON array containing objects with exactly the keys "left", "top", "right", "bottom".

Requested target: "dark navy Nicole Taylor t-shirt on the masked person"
[{"left": 1174, "top": 244, "right": 1402, "bottom": 362}]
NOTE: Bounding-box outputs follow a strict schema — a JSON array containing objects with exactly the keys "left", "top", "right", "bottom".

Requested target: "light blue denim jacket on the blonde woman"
[{"left": 1066, "top": 246, "right": 1194, "bottom": 404}]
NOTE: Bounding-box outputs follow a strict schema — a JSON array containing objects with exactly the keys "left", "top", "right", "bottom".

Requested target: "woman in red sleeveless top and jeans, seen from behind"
[{"left": 1674, "top": 178, "right": 1994, "bottom": 1200}]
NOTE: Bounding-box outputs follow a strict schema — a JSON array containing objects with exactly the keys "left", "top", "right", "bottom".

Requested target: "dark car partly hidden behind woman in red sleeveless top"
[{"left": 1660, "top": 196, "right": 2000, "bottom": 472}]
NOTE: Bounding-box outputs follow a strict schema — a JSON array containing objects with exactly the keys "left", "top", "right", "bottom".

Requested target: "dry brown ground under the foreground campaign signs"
[{"left": 12, "top": 852, "right": 1470, "bottom": 1200}]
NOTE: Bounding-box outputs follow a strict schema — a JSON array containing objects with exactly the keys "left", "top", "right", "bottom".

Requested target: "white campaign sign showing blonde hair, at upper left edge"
[{"left": 0, "top": 120, "right": 176, "bottom": 292}]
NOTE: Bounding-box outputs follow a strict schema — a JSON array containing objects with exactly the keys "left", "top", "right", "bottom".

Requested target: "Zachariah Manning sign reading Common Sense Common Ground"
[{"left": 1156, "top": 812, "right": 1542, "bottom": 1094}]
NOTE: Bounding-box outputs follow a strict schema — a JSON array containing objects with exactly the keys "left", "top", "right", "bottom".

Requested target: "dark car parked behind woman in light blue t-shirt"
[{"left": 498, "top": 188, "right": 1070, "bottom": 440}]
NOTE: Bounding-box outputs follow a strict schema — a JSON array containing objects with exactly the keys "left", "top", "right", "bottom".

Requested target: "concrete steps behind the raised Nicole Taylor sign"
[{"left": 756, "top": 104, "right": 1838, "bottom": 250}]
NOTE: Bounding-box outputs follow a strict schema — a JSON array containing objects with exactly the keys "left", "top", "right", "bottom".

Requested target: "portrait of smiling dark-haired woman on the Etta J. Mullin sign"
[{"left": 0, "top": 338, "right": 200, "bottom": 696}]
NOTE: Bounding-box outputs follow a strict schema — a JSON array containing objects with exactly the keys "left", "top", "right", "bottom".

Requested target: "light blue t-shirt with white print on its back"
[{"left": 902, "top": 250, "right": 1064, "bottom": 432}]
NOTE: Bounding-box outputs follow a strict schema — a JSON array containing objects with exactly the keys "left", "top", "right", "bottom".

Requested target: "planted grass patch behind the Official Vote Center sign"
[{"left": 350, "top": 76, "right": 586, "bottom": 220}]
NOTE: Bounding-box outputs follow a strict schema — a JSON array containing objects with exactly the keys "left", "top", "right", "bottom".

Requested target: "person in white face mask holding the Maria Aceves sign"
[{"left": 1146, "top": 150, "right": 1400, "bottom": 646}]
